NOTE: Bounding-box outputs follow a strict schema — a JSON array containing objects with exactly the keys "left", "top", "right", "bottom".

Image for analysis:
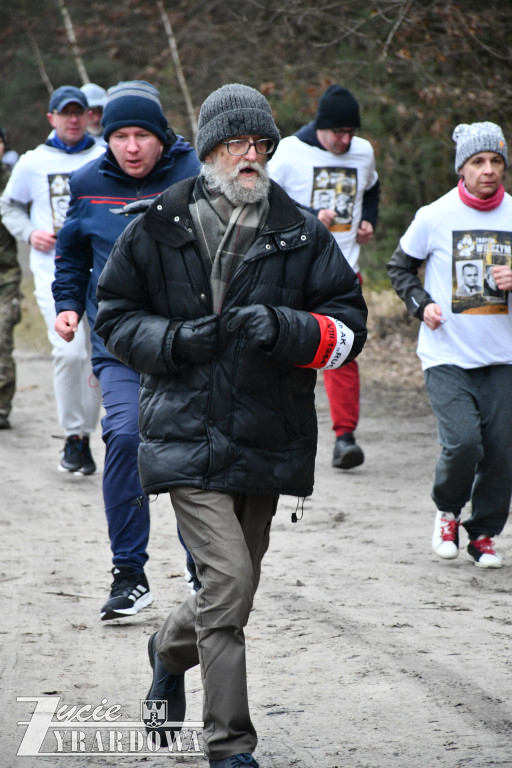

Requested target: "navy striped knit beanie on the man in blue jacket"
[{"left": 101, "top": 80, "right": 169, "bottom": 144}]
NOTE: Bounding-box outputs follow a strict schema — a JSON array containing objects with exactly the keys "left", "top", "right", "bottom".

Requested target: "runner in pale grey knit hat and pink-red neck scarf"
[{"left": 388, "top": 122, "right": 512, "bottom": 568}]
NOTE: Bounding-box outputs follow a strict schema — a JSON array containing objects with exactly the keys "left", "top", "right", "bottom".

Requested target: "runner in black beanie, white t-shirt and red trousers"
[{"left": 268, "top": 85, "right": 380, "bottom": 469}]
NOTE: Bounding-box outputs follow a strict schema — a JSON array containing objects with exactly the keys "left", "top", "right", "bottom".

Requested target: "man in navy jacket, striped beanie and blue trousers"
[{"left": 52, "top": 80, "right": 199, "bottom": 621}]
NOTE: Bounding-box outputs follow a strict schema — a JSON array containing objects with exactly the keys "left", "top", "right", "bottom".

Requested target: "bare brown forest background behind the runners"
[{"left": 0, "top": 0, "right": 512, "bottom": 290}]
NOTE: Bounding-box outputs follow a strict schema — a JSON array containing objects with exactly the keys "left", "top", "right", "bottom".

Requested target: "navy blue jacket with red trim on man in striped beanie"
[{"left": 52, "top": 136, "right": 200, "bottom": 365}]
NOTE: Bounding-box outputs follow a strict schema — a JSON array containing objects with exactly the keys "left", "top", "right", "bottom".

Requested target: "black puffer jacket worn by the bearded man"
[{"left": 96, "top": 179, "right": 367, "bottom": 496}]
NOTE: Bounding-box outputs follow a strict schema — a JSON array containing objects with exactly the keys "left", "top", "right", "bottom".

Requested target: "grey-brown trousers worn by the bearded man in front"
[{"left": 156, "top": 487, "right": 279, "bottom": 760}]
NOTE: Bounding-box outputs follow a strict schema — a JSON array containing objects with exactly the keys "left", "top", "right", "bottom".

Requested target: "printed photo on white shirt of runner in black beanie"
[{"left": 311, "top": 167, "right": 357, "bottom": 232}]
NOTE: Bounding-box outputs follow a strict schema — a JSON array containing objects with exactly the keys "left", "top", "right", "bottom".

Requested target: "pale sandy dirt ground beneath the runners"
[{"left": 0, "top": 278, "right": 512, "bottom": 768}]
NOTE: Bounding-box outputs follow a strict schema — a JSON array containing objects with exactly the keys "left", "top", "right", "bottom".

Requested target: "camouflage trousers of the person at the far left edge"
[{"left": 0, "top": 283, "right": 21, "bottom": 416}]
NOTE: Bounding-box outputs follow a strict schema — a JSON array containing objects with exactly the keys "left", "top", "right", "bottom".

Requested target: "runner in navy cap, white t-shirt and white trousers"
[{"left": 0, "top": 85, "right": 105, "bottom": 475}]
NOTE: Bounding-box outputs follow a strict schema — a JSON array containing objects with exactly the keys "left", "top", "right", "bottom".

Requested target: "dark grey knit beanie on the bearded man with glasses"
[{"left": 196, "top": 83, "right": 281, "bottom": 161}]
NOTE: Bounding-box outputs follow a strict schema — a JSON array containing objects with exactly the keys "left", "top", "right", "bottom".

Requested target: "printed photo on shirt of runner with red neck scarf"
[{"left": 452, "top": 230, "right": 512, "bottom": 315}]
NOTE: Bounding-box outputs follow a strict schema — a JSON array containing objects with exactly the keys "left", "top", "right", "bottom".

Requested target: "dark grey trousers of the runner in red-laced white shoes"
[{"left": 425, "top": 365, "right": 512, "bottom": 539}]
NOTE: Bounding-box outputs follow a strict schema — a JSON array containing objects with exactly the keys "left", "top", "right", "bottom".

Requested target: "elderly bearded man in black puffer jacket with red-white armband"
[{"left": 96, "top": 84, "right": 366, "bottom": 768}]
